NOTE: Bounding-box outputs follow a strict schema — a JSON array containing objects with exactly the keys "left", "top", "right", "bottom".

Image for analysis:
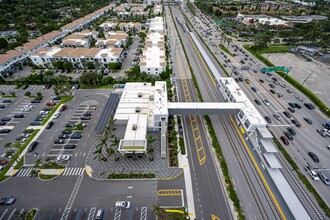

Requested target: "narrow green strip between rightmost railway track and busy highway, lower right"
[{"left": 273, "top": 134, "right": 330, "bottom": 217}]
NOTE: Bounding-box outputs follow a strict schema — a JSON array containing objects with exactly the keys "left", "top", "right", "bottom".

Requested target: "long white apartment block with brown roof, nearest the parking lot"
[{"left": 30, "top": 47, "right": 123, "bottom": 68}]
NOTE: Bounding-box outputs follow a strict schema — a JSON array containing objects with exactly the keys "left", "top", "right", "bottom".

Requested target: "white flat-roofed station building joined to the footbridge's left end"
[{"left": 114, "top": 82, "right": 168, "bottom": 155}]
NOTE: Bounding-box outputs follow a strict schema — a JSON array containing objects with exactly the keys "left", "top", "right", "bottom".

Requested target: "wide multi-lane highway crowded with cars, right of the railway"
[{"left": 188, "top": 4, "right": 330, "bottom": 209}]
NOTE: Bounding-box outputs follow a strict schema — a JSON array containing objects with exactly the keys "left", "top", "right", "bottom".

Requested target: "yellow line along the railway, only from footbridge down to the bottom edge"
[{"left": 229, "top": 116, "right": 286, "bottom": 220}]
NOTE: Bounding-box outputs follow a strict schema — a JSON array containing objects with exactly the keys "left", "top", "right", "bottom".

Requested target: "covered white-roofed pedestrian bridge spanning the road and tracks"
[{"left": 167, "top": 102, "right": 245, "bottom": 115}]
